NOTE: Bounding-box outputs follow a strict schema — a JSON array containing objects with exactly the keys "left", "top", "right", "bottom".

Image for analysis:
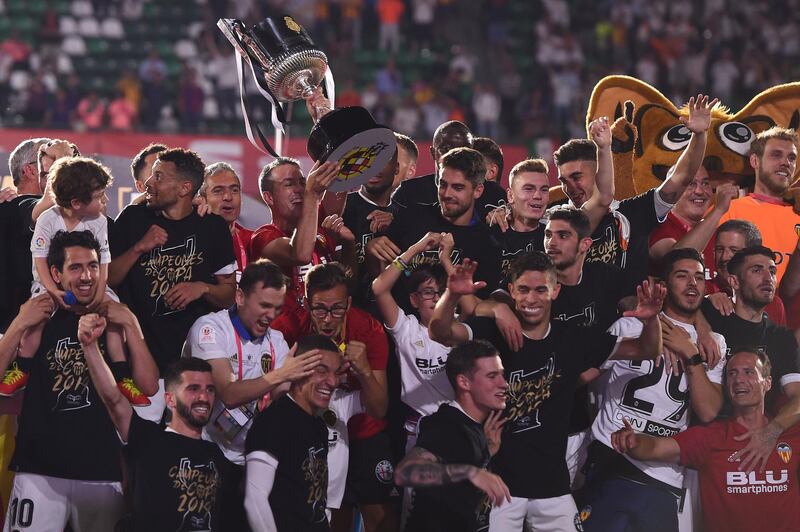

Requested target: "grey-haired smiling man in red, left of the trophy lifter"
[{"left": 198, "top": 163, "right": 253, "bottom": 283}]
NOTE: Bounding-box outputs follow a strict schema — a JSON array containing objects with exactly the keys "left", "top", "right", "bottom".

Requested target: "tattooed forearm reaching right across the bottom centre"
[{"left": 394, "top": 447, "right": 511, "bottom": 506}]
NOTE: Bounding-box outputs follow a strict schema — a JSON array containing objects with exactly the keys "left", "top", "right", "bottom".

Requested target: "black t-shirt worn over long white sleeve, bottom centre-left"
[{"left": 245, "top": 395, "right": 328, "bottom": 532}]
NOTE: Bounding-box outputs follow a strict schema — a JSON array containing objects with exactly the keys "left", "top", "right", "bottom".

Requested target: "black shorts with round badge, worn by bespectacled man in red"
[{"left": 342, "top": 430, "right": 400, "bottom": 505}]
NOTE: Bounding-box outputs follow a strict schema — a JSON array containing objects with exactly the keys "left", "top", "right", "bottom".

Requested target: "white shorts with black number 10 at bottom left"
[{"left": 3, "top": 473, "right": 125, "bottom": 532}]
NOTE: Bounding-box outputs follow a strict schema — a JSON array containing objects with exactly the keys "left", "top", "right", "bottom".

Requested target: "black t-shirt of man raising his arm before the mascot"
[{"left": 586, "top": 189, "right": 660, "bottom": 283}]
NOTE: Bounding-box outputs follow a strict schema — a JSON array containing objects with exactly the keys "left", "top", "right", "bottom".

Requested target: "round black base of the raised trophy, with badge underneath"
[{"left": 306, "top": 107, "right": 397, "bottom": 192}]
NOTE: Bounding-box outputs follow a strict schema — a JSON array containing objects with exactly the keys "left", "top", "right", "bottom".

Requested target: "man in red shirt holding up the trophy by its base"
[{"left": 249, "top": 157, "right": 353, "bottom": 313}]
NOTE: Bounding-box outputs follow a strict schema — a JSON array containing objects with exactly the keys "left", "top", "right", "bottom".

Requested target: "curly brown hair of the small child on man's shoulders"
[{"left": 50, "top": 157, "right": 112, "bottom": 209}]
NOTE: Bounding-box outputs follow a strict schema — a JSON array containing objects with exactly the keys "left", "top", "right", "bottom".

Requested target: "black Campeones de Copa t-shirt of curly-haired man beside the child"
[{"left": 109, "top": 205, "right": 235, "bottom": 373}]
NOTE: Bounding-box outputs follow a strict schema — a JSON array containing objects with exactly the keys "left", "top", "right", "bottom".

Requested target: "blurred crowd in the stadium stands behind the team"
[{"left": 0, "top": 0, "right": 800, "bottom": 144}]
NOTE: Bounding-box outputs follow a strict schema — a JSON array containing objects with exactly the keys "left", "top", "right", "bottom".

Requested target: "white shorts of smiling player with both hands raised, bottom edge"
[{"left": 489, "top": 495, "right": 583, "bottom": 532}]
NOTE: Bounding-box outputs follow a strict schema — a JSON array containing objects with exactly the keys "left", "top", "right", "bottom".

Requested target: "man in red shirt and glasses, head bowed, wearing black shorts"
[{"left": 272, "top": 262, "right": 399, "bottom": 532}]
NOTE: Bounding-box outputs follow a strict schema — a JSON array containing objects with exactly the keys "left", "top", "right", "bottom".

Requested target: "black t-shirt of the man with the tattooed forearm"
[{"left": 406, "top": 404, "right": 492, "bottom": 532}]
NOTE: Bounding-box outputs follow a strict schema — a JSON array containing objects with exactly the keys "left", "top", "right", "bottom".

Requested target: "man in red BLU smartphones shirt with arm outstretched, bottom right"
[{"left": 608, "top": 351, "right": 800, "bottom": 532}]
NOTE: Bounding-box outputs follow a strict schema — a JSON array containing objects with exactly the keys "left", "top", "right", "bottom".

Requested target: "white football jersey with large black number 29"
[{"left": 592, "top": 314, "right": 726, "bottom": 488}]
